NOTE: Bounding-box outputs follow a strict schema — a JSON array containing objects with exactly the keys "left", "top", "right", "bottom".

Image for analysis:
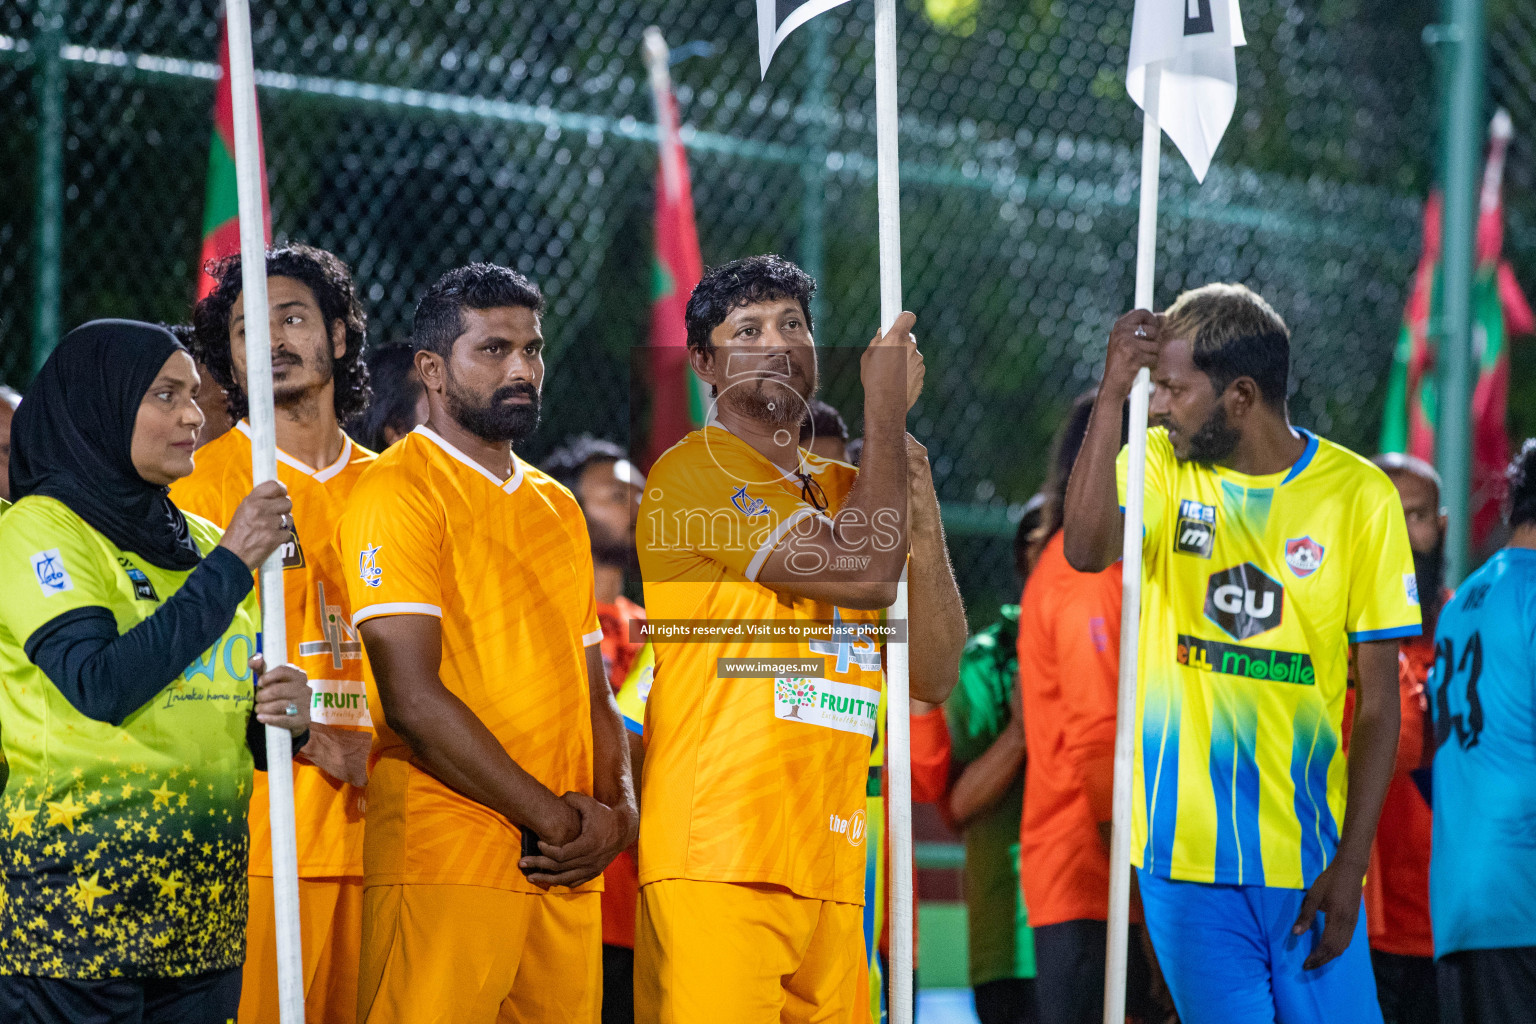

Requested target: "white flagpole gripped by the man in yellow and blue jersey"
[{"left": 1104, "top": 61, "right": 1163, "bottom": 1024}]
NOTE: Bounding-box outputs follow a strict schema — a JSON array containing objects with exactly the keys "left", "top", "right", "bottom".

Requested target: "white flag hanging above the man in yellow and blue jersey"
[{"left": 1130, "top": 0, "right": 1247, "bottom": 181}]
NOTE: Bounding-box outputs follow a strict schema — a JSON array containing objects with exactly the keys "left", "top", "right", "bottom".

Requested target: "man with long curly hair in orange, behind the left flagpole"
[{"left": 172, "top": 246, "right": 373, "bottom": 1024}]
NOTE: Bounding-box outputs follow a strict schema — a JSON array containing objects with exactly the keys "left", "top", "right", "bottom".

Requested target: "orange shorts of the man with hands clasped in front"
[{"left": 358, "top": 886, "right": 602, "bottom": 1024}]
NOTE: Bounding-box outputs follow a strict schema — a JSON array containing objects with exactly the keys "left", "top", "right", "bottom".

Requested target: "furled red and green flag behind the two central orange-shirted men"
[{"left": 645, "top": 42, "right": 707, "bottom": 470}]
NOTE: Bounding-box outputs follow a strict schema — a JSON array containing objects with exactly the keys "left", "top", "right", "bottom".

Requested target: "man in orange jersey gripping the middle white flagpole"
[{"left": 634, "top": 256, "right": 965, "bottom": 1024}]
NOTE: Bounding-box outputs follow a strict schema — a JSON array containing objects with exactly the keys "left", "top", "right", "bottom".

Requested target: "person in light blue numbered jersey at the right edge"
[{"left": 1430, "top": 439, "right": 1536, "bottom": 1024}]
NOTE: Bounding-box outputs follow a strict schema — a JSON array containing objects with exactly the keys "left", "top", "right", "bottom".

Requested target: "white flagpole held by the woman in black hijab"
[{"left": 226, "top": 0, "right": 304, "bottom": 1024}]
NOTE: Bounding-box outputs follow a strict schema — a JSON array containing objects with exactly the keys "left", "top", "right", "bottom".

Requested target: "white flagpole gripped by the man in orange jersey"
[{"left": 871, "top": 0, "right": 912, "bottom": 1024}]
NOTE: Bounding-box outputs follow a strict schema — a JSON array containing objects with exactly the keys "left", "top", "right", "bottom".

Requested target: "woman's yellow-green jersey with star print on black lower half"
[{"left": 0, "top": 496, "right": 260, "bottom": 979}]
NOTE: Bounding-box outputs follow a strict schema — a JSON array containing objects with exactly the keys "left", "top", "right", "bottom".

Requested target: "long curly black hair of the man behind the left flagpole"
[{"left": 192, "top": 243, "right": 370, "bottom": 424}]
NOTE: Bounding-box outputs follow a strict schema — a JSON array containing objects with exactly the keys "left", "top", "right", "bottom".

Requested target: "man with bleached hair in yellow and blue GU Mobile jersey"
[{"left": 1066, "top": 284, "right": 1419, "bottom": 1024}]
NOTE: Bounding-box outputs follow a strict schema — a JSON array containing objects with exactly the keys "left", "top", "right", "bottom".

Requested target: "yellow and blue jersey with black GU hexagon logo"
[{"left": 1120, "top": 428, "right": 1419, "bottom": 889}]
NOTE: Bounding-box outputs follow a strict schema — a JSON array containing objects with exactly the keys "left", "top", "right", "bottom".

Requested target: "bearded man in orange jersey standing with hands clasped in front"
[{"left": 339, "top": 264, "right": 637, "bottom": 1024}]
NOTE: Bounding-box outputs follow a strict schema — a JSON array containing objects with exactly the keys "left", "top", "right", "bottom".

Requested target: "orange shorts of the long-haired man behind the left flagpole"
[{"left": 240, "top": 875, "right": 362, "bottom": 1024}]
